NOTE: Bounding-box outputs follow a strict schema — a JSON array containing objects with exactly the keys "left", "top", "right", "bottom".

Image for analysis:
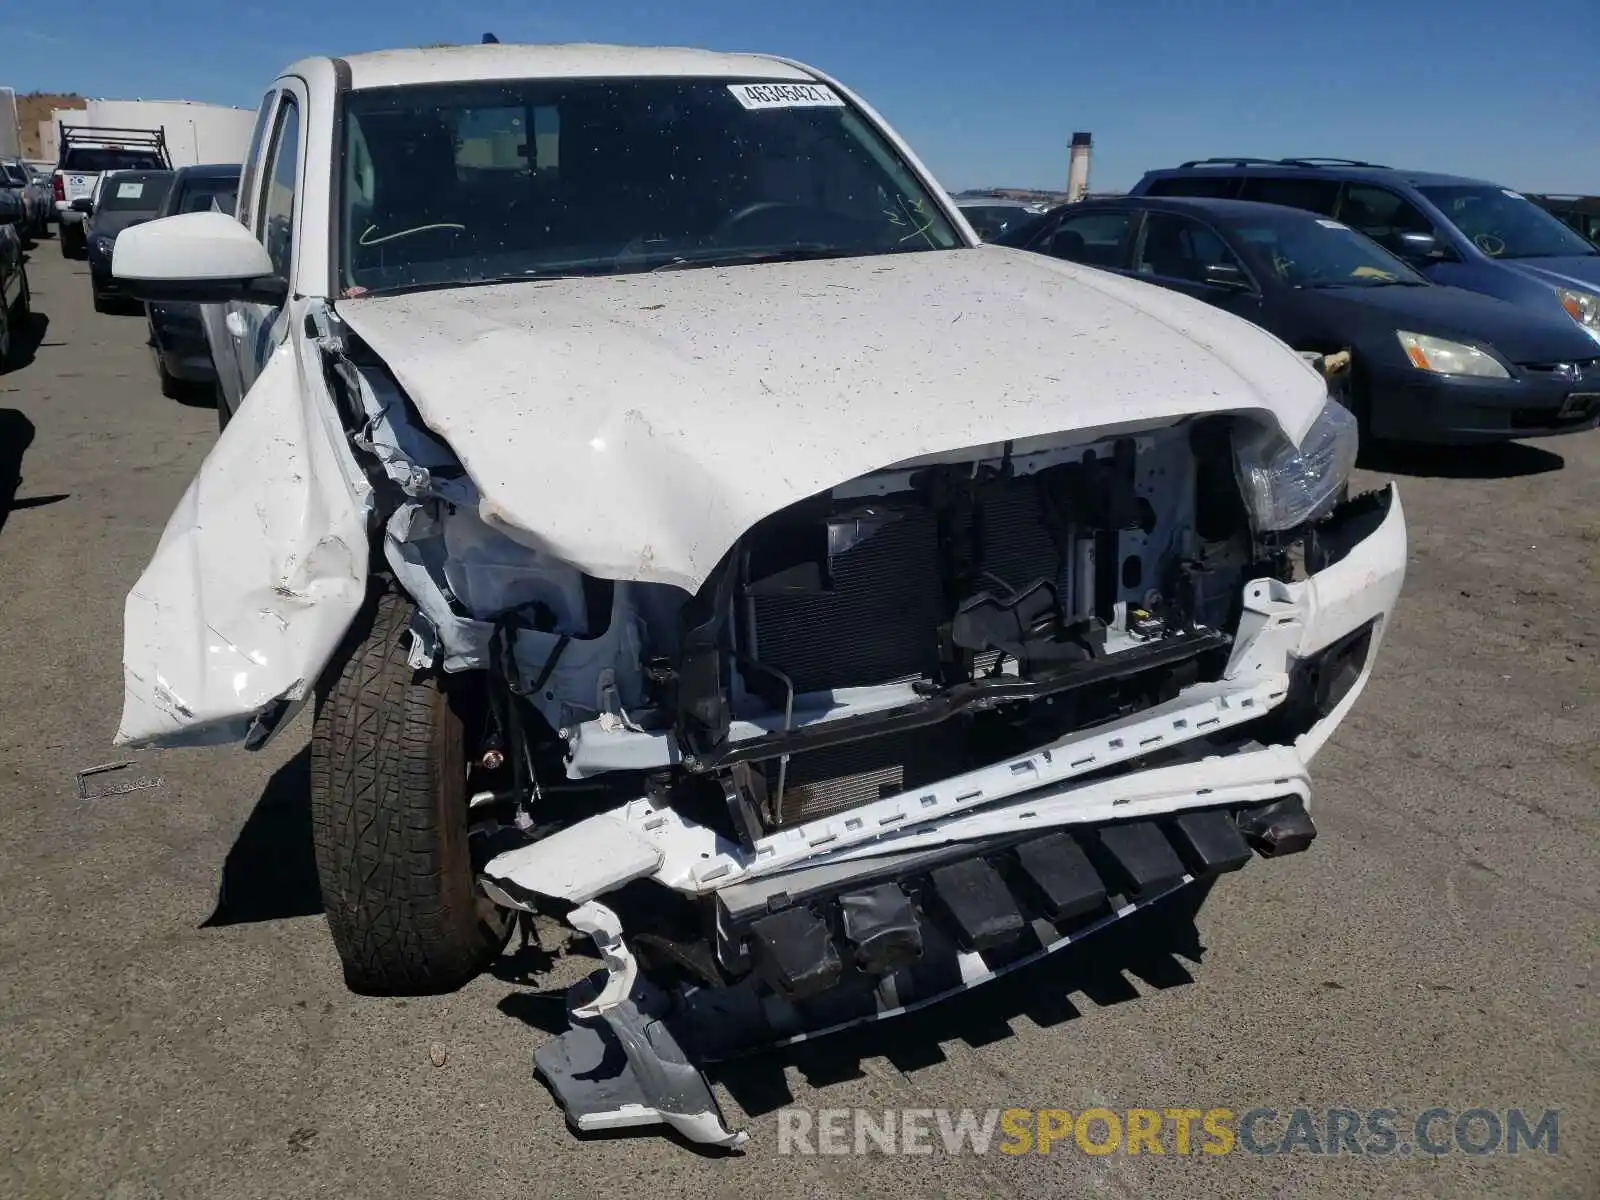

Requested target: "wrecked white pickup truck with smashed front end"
[{"left": 114, "top": 45, "right": 1406, "bottom": 1146}]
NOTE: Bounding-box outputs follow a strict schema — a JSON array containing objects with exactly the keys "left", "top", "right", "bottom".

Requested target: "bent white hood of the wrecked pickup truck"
[{"left": 338, "top": 246, "right": 1326, "bottom": 590}]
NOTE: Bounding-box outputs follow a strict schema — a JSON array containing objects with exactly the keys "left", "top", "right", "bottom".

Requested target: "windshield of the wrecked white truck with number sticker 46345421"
[{"left": 339, "top": 78, "right": 962, "bottom": 291}]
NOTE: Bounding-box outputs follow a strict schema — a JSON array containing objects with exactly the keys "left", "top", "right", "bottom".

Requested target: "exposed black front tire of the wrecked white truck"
[{"left": 310, "top": 587, "right": 512, "bottom": 995}]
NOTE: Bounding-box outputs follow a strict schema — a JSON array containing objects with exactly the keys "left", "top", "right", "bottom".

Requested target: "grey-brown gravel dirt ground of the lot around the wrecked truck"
[{"left": 0, "top": 242, "right": 1600, "bottom": 1200}]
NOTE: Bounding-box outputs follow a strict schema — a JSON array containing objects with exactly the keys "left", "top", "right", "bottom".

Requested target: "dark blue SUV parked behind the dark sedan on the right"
[{"left": 1131, "top": 158, "right": 1600, "bottom": 346}]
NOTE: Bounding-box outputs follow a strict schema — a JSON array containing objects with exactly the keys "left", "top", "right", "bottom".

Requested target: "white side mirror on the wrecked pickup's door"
[{"left": 110, "top": 213, "right": 290, "bottom": 304}]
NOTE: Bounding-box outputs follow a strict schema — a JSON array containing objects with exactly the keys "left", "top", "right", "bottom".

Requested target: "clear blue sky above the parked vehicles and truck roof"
[{"left": 0, "top": 0, "right": 1600, "bottom": 192}]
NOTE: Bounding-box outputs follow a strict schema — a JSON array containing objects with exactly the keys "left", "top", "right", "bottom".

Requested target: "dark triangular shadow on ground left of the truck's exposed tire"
[{"left": 202, "top": 747, "right": 322, "bottom": 928}]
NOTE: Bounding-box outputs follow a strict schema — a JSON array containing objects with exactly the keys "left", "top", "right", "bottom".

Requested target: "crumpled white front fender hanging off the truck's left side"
[{"left": 117, "top": 329, "right": 371, "bottom": 747}]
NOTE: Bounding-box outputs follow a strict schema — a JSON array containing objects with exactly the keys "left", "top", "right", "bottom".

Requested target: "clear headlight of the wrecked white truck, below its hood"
[{"left": 1234, "top": 398, "right": 1360, "bottom": 531}]
